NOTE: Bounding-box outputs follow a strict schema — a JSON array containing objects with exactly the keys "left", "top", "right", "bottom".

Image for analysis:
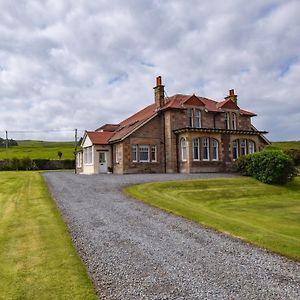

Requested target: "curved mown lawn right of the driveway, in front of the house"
[{"left": 125, "top": 177, "right": 300, "bottom": 261}]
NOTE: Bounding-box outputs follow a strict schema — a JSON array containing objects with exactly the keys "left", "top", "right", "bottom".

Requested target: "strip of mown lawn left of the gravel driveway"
[{"left": 0, "top": 172, "right": 97, "bottom": 300}]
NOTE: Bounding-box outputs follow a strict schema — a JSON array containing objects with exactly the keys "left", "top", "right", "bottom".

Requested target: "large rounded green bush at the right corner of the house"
[{"left": 235, "top": 150, "right": 296, "bottom": 184}]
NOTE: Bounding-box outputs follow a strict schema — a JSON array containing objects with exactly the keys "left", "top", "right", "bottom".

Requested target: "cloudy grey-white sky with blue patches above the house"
[{"left": 0, "top": 0, "right": 300, "bottom": 141}]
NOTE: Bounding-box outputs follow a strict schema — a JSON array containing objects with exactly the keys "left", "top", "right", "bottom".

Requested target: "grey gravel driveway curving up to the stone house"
[{"left": 44, "top": 173, "right": 300, "bottom": 300}]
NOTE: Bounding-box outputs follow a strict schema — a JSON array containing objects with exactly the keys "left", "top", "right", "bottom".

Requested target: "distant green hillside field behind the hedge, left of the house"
[{"left": 0, "top": 141, "right": 74, "bottom": 160}]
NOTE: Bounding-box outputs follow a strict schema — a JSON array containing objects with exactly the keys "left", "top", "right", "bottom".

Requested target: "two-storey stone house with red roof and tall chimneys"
[{"left": 76, "top": 76, "right": 269, "bottom": 174}]
